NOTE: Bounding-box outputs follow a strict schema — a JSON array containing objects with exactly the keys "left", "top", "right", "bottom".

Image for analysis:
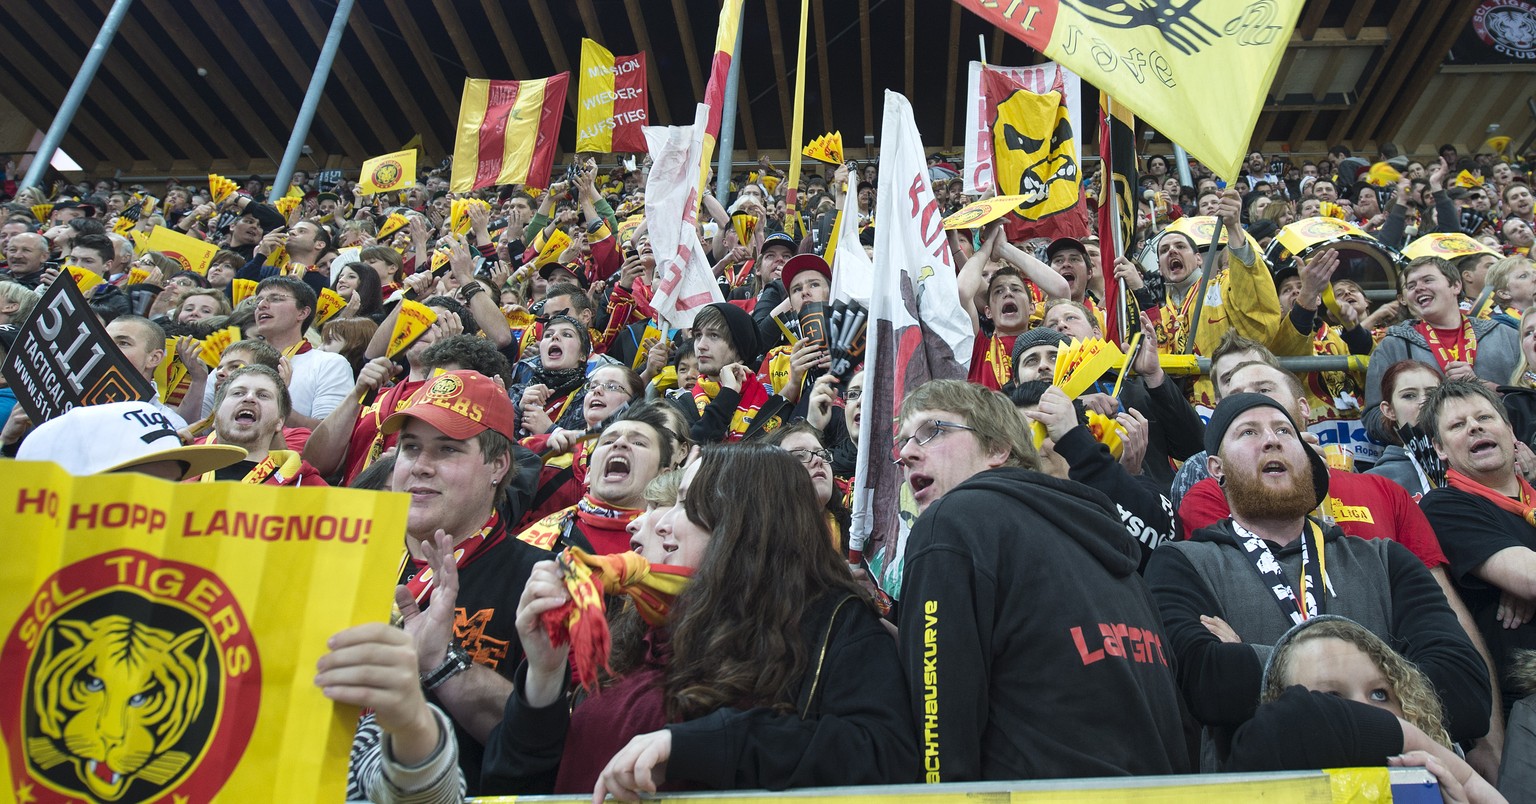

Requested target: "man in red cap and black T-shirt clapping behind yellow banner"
[{"left": 356, "top": 370, "right": 550, "bottom": 795}]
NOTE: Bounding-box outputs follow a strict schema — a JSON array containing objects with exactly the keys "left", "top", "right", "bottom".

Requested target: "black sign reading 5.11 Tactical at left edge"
[{"left": 0, "top": 275, "right": 155, "bottom": 424}]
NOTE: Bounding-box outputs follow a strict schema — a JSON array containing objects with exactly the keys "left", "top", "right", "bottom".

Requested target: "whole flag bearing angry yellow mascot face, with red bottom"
[{"left": 982, "top": 69, "right": 1087, "bottom": 240}]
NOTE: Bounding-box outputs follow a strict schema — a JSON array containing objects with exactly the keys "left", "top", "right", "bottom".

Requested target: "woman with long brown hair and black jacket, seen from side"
[{"left": 481, "top": 444, "right": 919, "bottom": 798}]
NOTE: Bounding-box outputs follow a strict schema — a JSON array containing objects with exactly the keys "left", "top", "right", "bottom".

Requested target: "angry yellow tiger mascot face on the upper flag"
[{"left": 992, "top": 91, "right": 1078, "bottom": 220}]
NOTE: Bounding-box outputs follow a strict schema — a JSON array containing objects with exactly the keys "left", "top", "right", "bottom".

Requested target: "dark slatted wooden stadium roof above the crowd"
[{"left": 0, "top": 0, "right": 1536, "bottom": 177}]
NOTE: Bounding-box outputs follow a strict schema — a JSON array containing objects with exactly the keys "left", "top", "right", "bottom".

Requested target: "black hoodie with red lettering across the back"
[{"left": 900, "top": 467, "right": 1189, "bottom": 782}]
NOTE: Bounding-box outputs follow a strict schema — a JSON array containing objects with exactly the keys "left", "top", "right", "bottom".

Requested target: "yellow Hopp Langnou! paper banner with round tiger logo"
[{"left": 0, "top": 461, "right": 409, "bottom": 804}]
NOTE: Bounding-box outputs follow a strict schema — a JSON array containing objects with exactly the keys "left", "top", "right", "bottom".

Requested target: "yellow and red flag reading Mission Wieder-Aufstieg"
[{"left": 576, "top": 38, "right": 650, "bottom": 154}]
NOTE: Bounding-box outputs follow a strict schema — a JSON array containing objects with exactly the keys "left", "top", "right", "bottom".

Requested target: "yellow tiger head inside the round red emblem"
[{"left": 26, "top": 615, "right": 212, "bottom": 801}]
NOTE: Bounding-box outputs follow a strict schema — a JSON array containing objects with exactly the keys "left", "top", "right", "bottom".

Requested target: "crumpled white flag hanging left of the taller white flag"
[{"left": 644, "top": 103, "right": 725, "bottom": 327}]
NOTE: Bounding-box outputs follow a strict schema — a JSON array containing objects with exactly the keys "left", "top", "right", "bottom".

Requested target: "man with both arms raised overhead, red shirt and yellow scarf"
[{"left": 955, "top": 226, "right": 1072, "bottom": 390}]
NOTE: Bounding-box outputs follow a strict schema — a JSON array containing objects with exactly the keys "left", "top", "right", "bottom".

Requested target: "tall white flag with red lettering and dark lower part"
[{"left": 839, "top": 91, "right": 975, "bottom": 596}]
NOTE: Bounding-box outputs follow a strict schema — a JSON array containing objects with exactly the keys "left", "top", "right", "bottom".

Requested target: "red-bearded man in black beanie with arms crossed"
[{"left": 1146, "top": 394, "right": 1490, "bottom": 770}]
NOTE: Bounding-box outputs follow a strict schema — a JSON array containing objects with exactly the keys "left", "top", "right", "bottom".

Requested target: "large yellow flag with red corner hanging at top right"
[{"left": 955, "top": 0, "right": 1303, "bottom": 181}]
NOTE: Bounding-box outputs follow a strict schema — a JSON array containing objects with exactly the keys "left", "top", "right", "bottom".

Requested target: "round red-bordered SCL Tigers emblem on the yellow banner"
[{"left": 0, "top": 549, "right": 261, "bottom": 804}]
